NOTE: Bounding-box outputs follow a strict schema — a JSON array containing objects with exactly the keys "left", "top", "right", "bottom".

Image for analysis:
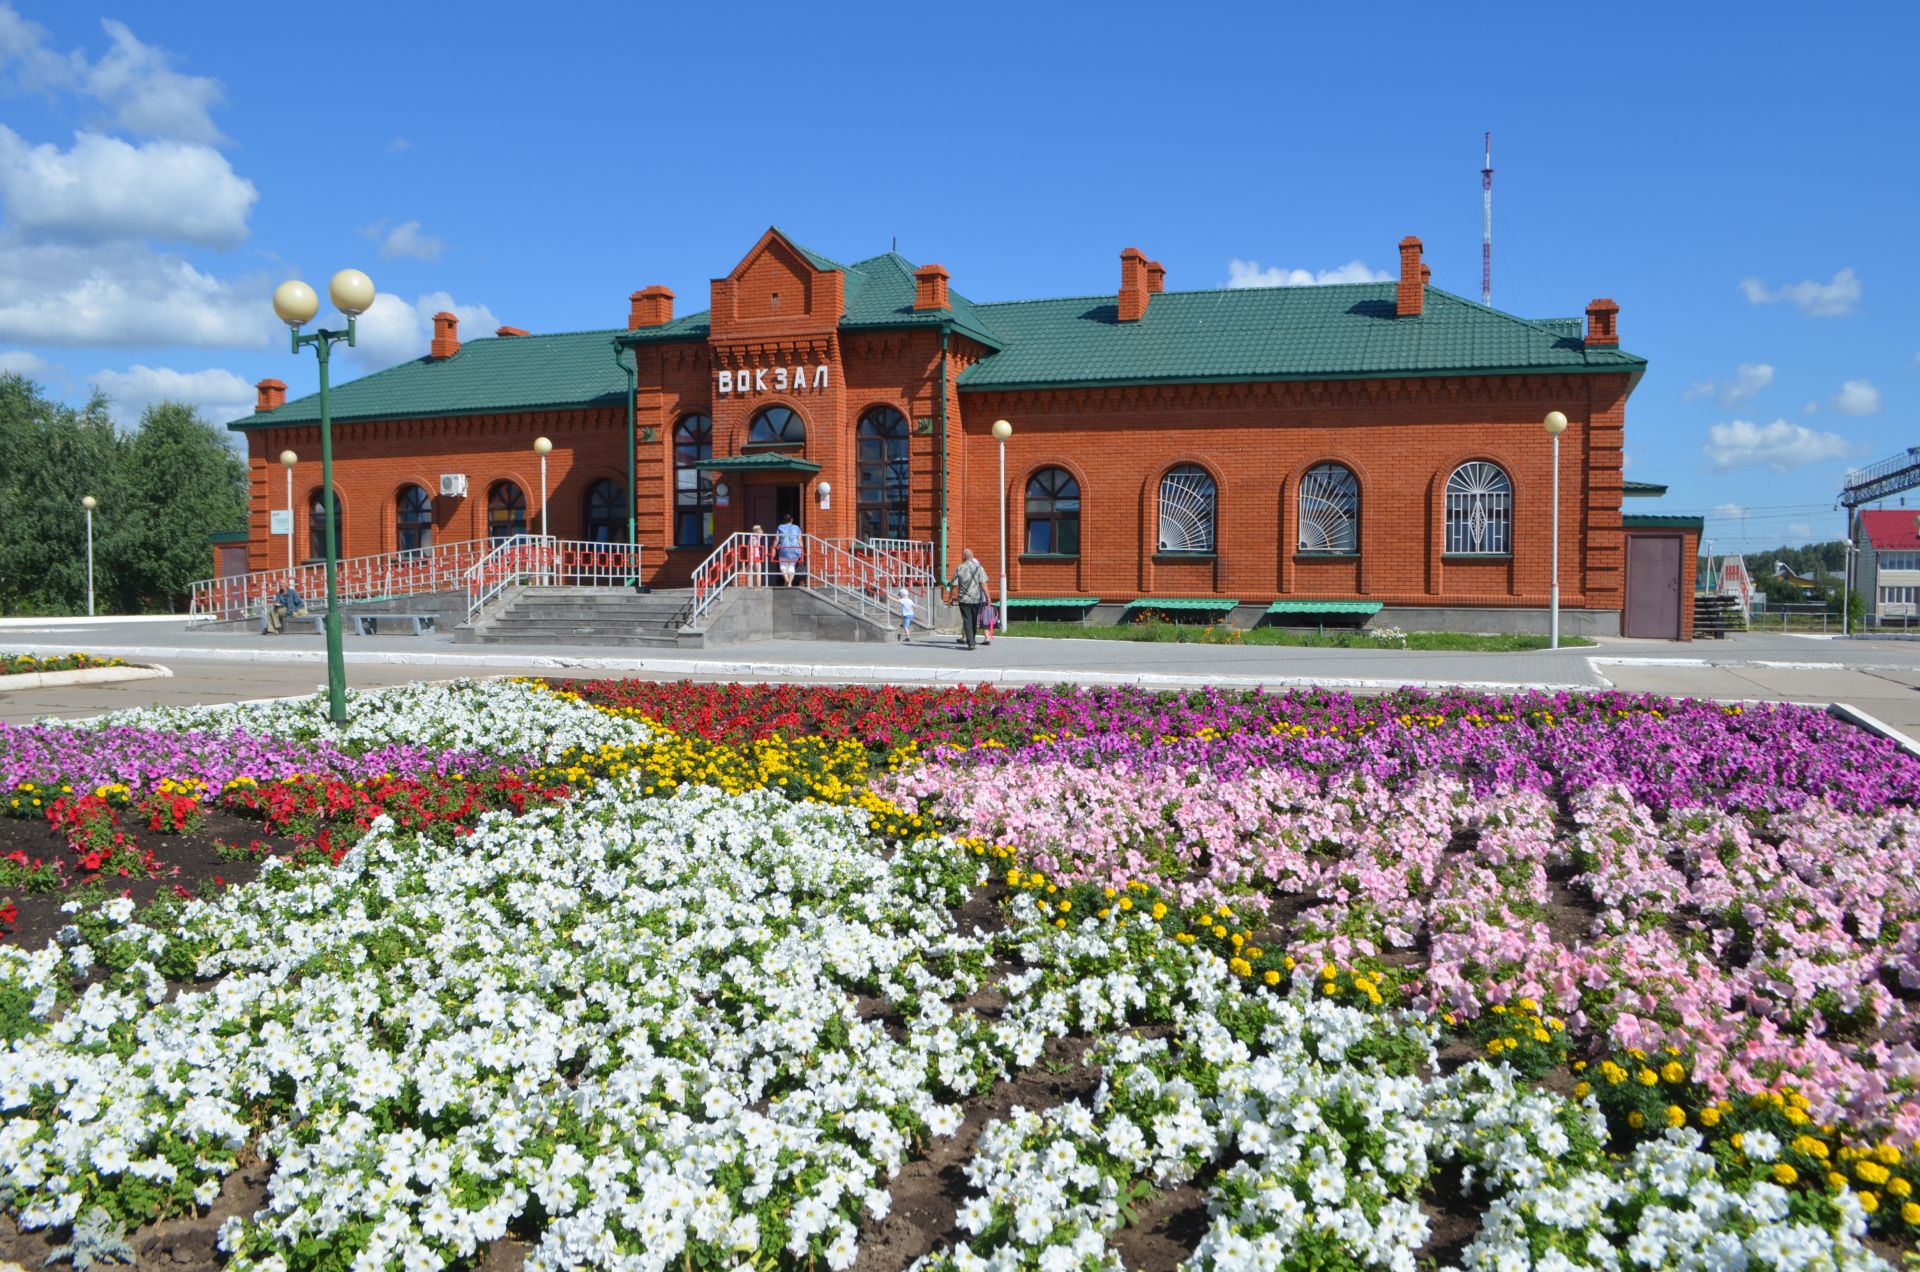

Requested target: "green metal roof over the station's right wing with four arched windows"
[{"left": 960, "top": 282, "right": 1647, "bottom": 390}]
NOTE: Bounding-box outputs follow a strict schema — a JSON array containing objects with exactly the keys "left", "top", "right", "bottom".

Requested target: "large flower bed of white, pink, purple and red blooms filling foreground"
[{"left": 0, "top": 682, "right": 1920, "bottom": 1268}]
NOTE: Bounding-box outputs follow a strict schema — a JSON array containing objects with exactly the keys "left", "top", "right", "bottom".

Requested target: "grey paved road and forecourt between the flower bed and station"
[{"left": 0, "top": 619, "right": 1920, "bottom": 732}]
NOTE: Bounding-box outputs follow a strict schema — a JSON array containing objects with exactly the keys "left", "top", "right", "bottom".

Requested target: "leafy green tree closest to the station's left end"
[{"left": 113, "top": 402, "right": 248, "bottom": 611}]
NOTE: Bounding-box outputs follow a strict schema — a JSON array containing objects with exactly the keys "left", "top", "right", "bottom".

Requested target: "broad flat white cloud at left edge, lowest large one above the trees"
[{"left": 0, "top": 240, "right": 278, "bottom": 348}]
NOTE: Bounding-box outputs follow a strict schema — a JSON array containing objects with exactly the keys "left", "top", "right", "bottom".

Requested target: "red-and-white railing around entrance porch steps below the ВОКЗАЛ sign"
[{"left": 682, "top": 534, "right": 939, "bottom": 630}]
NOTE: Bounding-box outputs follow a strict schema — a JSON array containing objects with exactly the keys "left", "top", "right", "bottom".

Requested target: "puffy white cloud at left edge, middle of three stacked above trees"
[{"left": 0, "top": 125, "right": 259, "bottom": 248}]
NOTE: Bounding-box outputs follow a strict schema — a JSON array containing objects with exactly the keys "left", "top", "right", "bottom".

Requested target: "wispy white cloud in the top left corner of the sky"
[{"left": 0, "top": 4, "right": 227, "bottom": 144}]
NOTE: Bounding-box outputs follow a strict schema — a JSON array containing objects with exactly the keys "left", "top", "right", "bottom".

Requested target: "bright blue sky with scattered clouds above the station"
[{"left": 0, "top": 0, "right": 1920, "bottom": 548}]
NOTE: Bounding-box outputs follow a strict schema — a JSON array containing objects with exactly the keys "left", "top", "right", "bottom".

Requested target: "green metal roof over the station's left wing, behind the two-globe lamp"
[{"left": 227, "top": 330, "right": 626, "bottom": 432}]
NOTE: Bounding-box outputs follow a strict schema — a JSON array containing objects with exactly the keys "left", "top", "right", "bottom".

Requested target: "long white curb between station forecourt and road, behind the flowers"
[{"left": 0, "top": 644, "right": 1597, "bottom": 694}]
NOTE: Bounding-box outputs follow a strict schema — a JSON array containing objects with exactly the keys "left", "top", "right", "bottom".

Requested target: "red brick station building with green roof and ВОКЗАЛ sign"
[{"left": 230, "top": 229, "right": 1699, "bottom": 638}]
